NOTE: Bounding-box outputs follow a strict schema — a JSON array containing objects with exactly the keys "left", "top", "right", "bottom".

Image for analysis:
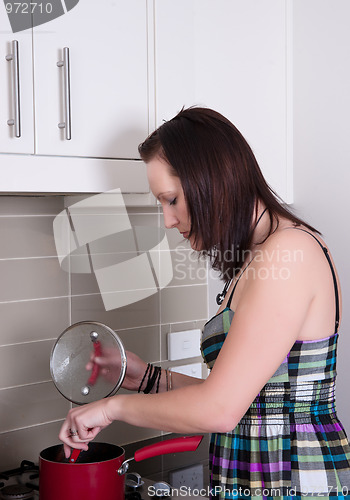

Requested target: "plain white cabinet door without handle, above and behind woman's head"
[{"left": 155, "top": 0, "right": 291, "bottom": 201}]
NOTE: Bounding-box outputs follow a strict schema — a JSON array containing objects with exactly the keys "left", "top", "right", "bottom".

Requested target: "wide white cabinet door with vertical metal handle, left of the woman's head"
[{"left": 34, "top": 0, "right": 148, "bottom": 158}]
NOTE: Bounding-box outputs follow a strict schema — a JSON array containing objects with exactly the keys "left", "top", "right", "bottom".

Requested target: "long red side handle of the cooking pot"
[{"left": 134, "top": 436, "right": 203, "bottom": 462}]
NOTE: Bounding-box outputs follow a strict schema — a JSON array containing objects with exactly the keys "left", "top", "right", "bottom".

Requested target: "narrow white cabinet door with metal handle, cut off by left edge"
[{"left": 0, "top": 4, "right": 34, "bottom": 153}]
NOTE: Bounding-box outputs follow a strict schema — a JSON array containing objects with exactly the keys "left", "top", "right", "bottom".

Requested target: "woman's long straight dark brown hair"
[{"left": 139, "top": 107, "right": 318, "bottom": 280}]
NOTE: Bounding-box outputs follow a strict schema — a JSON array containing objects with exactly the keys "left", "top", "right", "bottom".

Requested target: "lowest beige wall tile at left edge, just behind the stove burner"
[{"left": 0, "top": 421, "right": 63, "bottom": 470}]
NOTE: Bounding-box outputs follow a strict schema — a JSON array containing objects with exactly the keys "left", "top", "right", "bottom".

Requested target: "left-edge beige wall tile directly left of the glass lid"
[{"left": 0, "top": 340, "right": 54, "bottom": 389}]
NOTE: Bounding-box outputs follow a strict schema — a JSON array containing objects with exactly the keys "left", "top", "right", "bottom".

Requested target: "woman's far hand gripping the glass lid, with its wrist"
[{"left": 86, "top": 348, "right": 147, "bottom": 391}]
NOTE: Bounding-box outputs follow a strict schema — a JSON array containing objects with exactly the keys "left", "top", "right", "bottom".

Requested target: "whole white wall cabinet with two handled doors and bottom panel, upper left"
[{"left": 0, "top": 0, "right": 154, "bottom": 195}]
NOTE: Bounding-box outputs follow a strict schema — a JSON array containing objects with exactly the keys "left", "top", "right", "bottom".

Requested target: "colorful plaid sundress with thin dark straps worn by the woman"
[{"left": 201, "top": 233, "right": 350, "bottom": 500}]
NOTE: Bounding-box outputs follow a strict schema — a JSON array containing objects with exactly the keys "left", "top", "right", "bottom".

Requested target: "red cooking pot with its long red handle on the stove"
[{"left": 39, "top": 436, "right": 203, "bottom": 500}]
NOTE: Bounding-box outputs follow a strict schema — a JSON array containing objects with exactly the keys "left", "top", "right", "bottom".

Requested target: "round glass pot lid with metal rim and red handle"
[{"left": 50, "top": 321, "right": 126, "bottom": 405}]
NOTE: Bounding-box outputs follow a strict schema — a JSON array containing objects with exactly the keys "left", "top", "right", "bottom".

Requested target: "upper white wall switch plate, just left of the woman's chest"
[{"left": 168, "top": 328, "right": 201, "bottom": 361}]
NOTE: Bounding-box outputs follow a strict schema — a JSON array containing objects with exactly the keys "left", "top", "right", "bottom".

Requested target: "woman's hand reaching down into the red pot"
[{"left": 59, "top": 398, "right": 112, "bottom": 458}]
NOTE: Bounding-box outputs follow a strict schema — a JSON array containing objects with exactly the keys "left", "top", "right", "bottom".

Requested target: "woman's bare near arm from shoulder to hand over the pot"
[{"left": 60, "top": 231, "right": 323, "bottom": 458}]
